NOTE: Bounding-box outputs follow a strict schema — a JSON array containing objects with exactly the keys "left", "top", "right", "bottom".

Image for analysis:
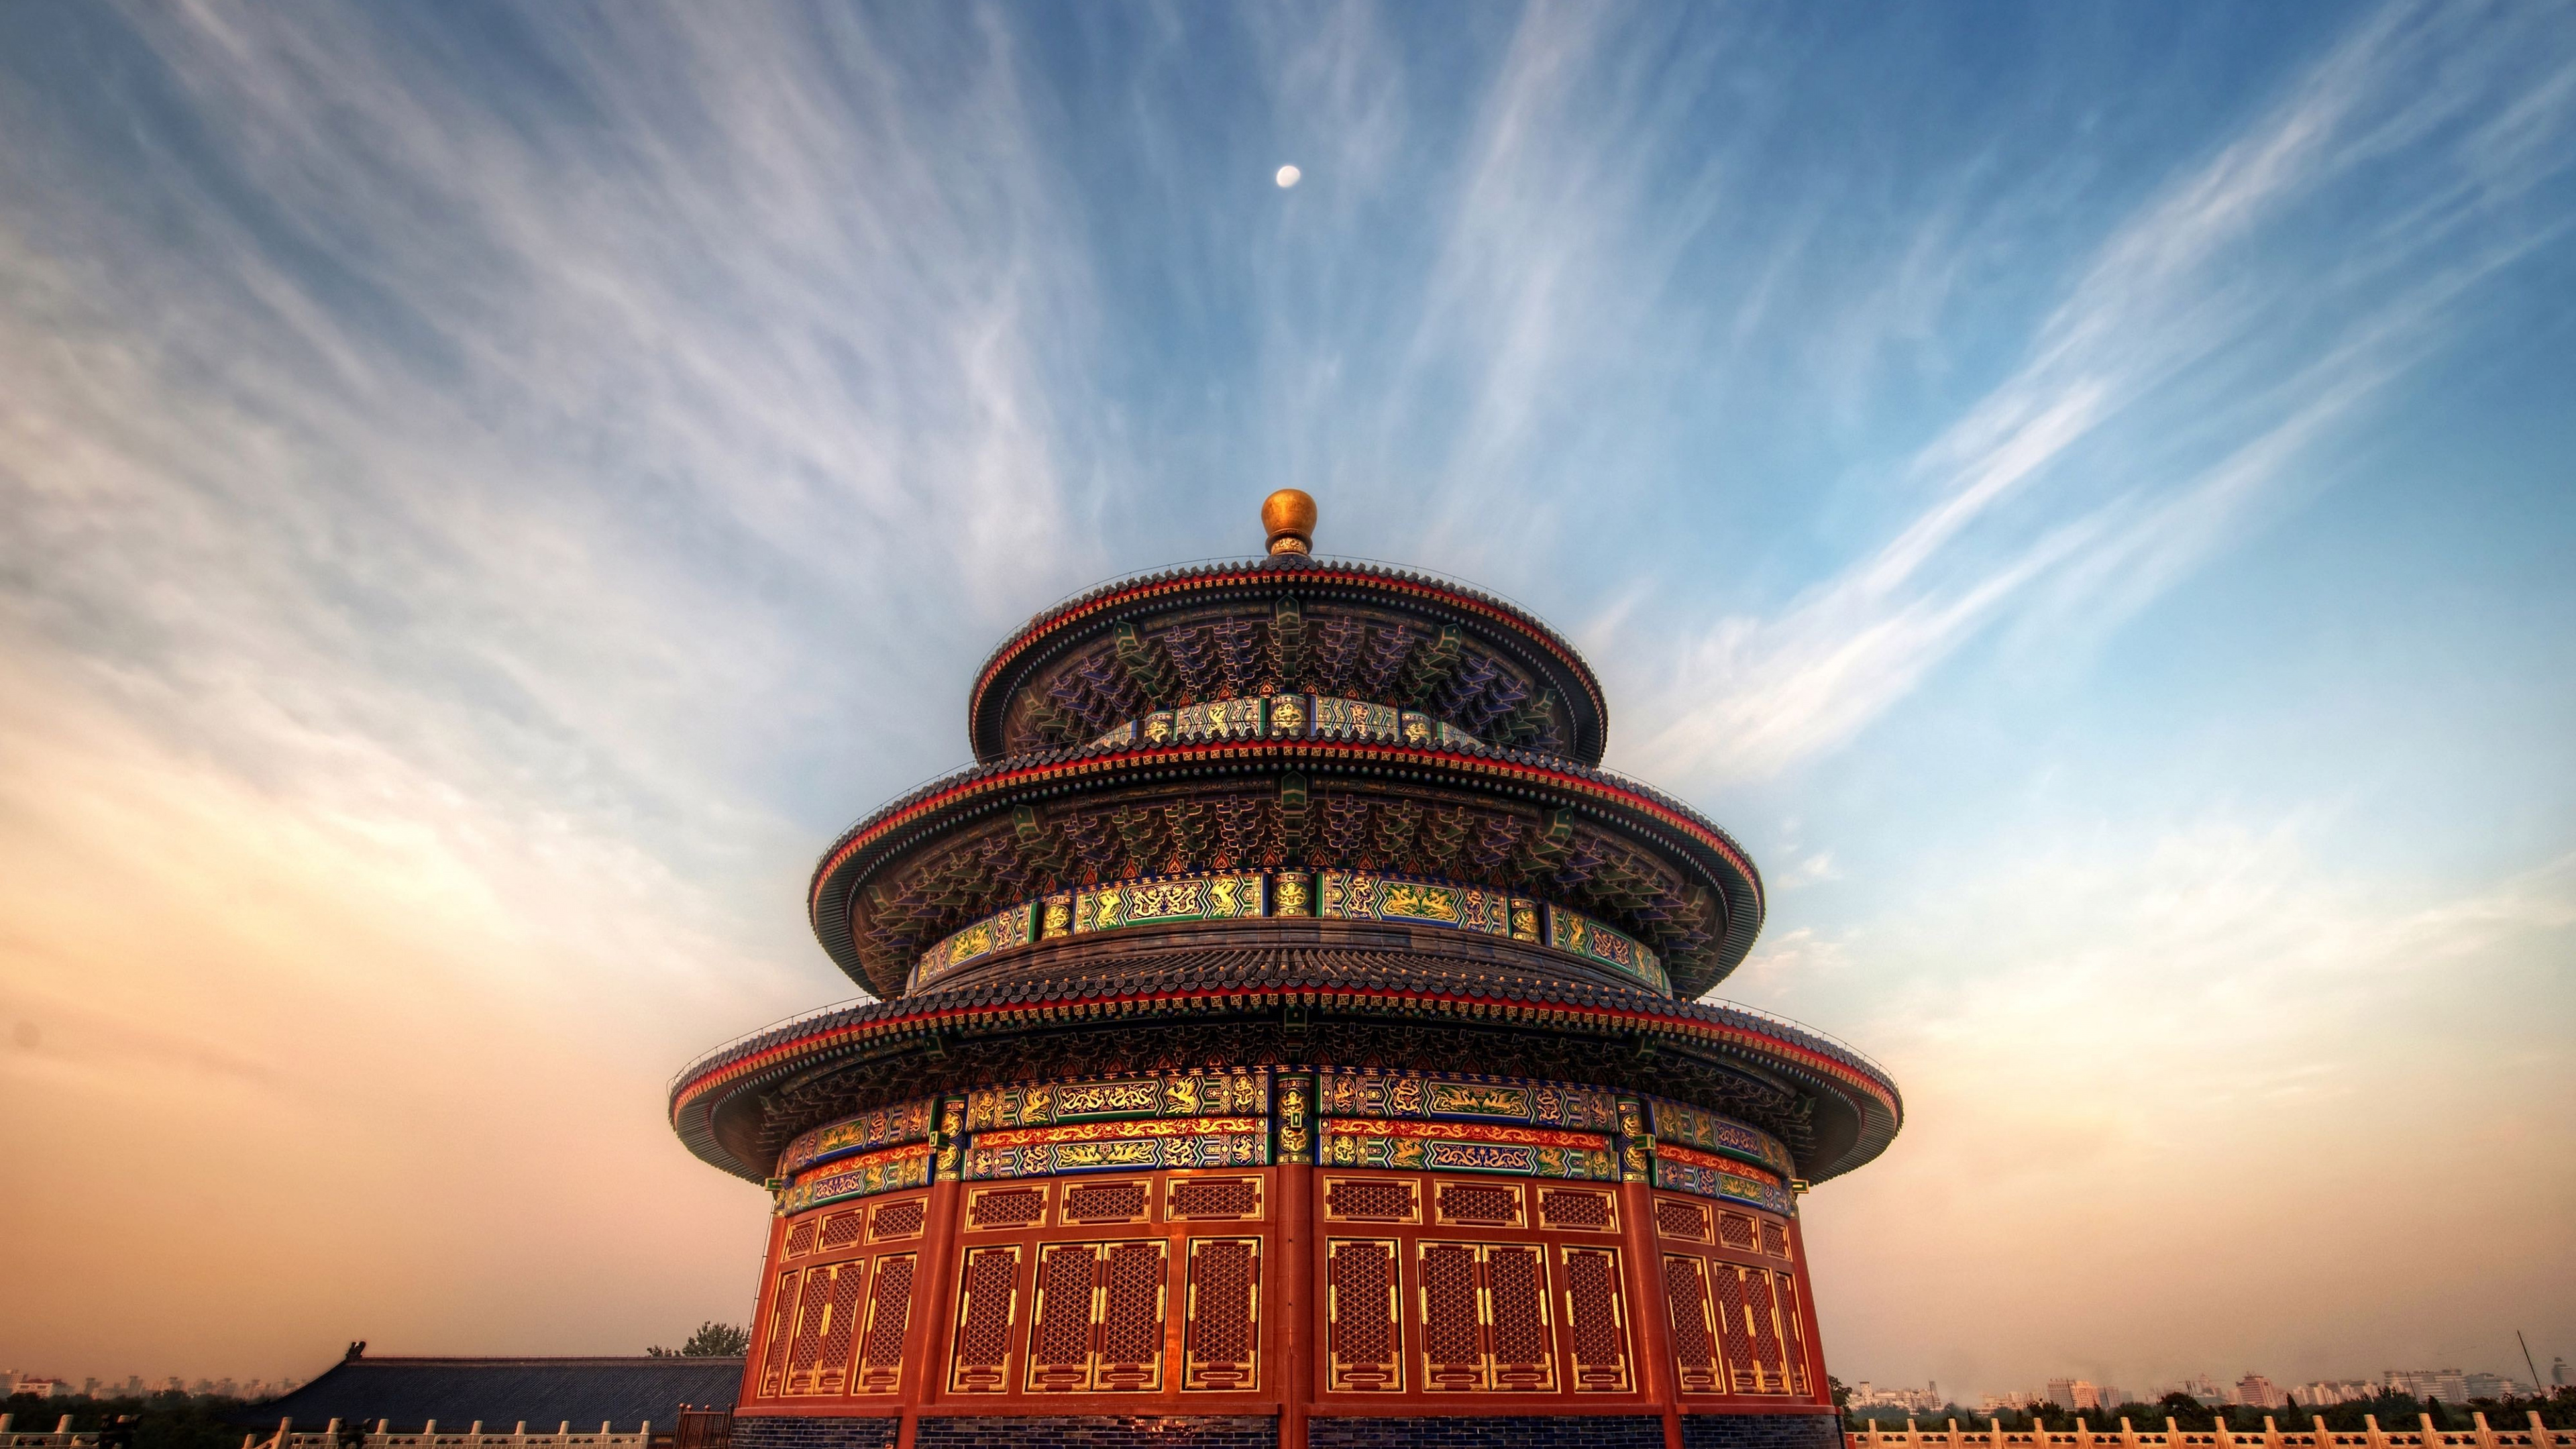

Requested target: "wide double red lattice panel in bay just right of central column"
[{"left": 1419, "top": 1227, "right": 1556, "bottom": 1392}]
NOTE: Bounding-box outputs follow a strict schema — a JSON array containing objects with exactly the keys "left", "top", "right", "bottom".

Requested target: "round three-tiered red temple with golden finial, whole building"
[{"left": 669, "top": 490, "right": 1904, "bottom": 1449}]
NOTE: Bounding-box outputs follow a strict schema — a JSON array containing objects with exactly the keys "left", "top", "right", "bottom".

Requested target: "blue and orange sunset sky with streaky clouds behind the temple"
[{"left": 0, "top": 0, "right": 2576, "bottom": 1403}]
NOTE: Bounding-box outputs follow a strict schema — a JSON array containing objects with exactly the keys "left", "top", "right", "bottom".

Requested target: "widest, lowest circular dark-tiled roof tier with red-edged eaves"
[{"left": 669, "top": 933, "right": 1904, "bottom": 1181}]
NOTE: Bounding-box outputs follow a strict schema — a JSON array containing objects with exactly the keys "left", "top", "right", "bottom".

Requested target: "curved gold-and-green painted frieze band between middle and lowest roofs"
[{"left": 904, "top": 869, "right": 1672, "bottom": 993}]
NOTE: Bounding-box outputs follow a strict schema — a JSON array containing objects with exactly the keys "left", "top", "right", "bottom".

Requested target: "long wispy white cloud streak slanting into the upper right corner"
[{"left": 1625, "top": 8, "right": 2576, "bottom": 779}]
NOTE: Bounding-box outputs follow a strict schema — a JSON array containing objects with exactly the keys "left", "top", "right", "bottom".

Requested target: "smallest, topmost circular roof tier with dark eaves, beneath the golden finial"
[{"left": 966, "top": 551, "right": 1610, "bottom": 765}]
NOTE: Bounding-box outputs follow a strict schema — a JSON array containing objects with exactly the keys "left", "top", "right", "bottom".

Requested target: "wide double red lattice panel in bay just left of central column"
[{"left": 1028, "top": 1238, "right": 1165, "bottom": 1392}]
